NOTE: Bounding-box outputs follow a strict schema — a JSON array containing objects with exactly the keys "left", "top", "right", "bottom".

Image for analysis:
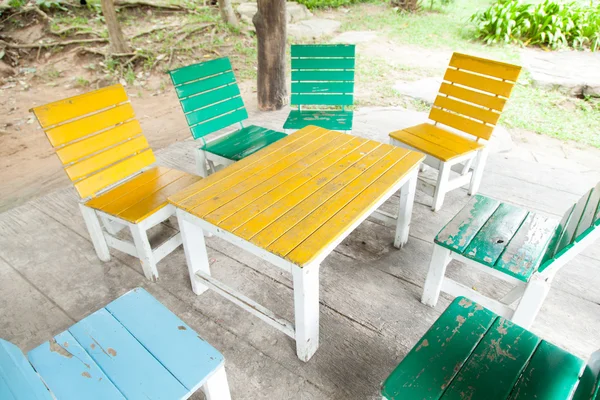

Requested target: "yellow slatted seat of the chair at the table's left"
[{"left": 85, "top": 167, "right": 202, "bottom": 223}]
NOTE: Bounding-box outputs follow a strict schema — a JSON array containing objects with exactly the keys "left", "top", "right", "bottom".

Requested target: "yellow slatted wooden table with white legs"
[{"left": 169, "top": 126, "right": 424, "bottom": 361}]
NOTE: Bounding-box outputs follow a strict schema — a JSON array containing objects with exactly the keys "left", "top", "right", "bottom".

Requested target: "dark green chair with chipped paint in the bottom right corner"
[{"left": 381, "top": 297, "right": 600, "bottom": 400}]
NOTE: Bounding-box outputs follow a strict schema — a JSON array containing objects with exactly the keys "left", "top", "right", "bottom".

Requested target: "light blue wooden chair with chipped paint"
[{"left": 0, "top": 288, "right": 230, "bottom": 400}]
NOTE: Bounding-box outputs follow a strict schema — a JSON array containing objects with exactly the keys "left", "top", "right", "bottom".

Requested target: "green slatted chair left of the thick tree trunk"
[{"left": 170, "top": 57, "right": 286, "bottom": 177}]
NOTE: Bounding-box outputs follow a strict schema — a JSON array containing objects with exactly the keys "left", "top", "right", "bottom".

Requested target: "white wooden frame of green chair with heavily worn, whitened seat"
[{"left": 421, "top": 222, "right": 600, "bottom": 329}]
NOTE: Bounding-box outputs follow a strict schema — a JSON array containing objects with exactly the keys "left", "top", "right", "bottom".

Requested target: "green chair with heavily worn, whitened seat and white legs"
[{"left": 422, "top": 183, "right": 600, "bottom": 328}]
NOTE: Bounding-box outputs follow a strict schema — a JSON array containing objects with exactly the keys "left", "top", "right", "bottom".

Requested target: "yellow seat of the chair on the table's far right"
[{"left": 390, "top": 123, "right": 483, "bottom": 161}]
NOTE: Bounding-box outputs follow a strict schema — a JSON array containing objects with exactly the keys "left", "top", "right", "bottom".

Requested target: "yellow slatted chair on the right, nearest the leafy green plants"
[{"left": 390, "top": 53, "right": 521, "bottom": 211}]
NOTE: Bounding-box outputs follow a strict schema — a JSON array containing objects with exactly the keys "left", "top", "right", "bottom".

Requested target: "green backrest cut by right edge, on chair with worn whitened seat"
[{"left": 539, "top": 183, "right": 600, "bottom": 272}]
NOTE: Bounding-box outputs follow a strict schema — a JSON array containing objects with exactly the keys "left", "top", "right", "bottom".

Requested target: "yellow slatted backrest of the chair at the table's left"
[{"left": 31, "top": 85, "right": 155, "bottom": 198}]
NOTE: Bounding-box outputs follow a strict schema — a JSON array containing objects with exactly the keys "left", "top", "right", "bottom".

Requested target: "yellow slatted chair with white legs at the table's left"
[{"left": 31, "top": 85, "right": 200, "bottom": 281}]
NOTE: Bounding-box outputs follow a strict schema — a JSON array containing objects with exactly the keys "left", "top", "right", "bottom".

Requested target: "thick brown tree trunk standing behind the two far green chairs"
[{"left": 252, "top": 0, "right": 288, "bottom": 111}]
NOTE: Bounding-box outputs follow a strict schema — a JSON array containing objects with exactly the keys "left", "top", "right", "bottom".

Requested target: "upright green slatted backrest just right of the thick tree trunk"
[{"left": 291, "top": 44, "right": 355, "bottom": 108}]
